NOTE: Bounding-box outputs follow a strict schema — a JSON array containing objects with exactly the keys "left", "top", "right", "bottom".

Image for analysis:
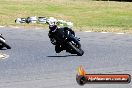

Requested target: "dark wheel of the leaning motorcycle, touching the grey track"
[{"left": 68, "top": 38, "right": 84, "bottom": 56}]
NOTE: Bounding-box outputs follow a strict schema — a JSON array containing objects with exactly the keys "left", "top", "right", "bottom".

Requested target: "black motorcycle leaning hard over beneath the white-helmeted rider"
[{"left": 49, "top": 25, "right": 84, "bottom": 56}]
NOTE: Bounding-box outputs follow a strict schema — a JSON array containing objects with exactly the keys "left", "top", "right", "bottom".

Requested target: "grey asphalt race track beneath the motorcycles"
[{"left": 0, "top": 28, "right": 132, "bottom": 88}]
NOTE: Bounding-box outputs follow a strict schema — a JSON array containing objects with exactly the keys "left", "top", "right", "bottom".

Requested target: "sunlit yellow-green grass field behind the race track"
[{"left": 0, "top": 0, "right": 132, "bottom": 32}]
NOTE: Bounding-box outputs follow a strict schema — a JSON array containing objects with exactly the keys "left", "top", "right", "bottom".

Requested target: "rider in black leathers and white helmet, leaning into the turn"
[{"left": 47, "top": 17, "right": 75, "bottom": 53}]
